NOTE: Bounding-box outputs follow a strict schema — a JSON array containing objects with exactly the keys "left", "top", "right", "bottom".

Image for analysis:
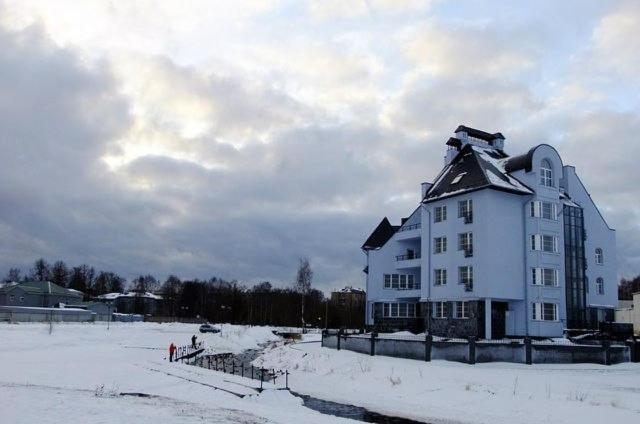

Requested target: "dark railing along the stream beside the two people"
[{"left": 190, "top": 354, "right": 289, "bottom": 390}]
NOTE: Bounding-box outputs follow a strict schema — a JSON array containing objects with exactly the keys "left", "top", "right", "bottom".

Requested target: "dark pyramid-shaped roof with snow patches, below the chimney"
[{"left": 423, "top": 144, "right": 533, "bottom": 202}]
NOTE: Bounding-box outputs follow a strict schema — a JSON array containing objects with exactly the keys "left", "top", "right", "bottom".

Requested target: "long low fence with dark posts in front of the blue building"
[{"left": 322, "top": 331, "right": 640, "bottom": 365}]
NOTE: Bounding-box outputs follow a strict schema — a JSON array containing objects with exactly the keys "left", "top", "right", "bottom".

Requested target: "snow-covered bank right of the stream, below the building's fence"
[{"left": 256, "top": 336, "right": 640, "bottom": 424}]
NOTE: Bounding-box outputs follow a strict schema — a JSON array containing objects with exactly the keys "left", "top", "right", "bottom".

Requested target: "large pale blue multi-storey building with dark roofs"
[{"left": 362, "top": 126, "right": 617, "bottom": 338}]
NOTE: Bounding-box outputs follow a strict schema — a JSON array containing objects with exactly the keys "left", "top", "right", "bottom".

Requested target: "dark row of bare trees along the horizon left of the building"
[{"left": 4, "top": 258, "right": 365, "bottom": 328}]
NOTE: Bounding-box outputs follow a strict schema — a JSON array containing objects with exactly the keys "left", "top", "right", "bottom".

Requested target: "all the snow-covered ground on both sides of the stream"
[{"left": 0, "top": 323, "right": 640, "bottom": 424}]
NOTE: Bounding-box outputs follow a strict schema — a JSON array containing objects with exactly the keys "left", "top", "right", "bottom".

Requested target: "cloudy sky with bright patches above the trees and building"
[{"left": 0, "top": 0, "right": 640, "bottom": 291}]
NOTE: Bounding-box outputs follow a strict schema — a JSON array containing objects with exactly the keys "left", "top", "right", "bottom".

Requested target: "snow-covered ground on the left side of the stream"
[{"left": 0, "top": 323, "right": 346, "bottom": 424}]
